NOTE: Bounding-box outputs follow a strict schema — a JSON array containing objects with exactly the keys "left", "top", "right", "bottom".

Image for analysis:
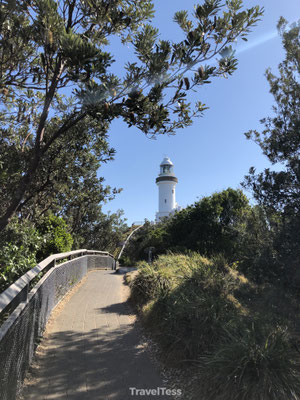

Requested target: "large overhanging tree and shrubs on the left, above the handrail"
[{"left": 0, "top": 0, "right": 263, "bottom": 287}]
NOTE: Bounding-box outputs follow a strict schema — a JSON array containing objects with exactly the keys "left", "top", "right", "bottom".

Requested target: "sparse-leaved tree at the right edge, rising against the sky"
[{"left": 244, "top": 18, "right": 300, "bottom": 278}]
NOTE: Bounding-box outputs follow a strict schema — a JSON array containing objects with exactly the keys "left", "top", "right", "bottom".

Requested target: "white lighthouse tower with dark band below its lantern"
[{"left": 156, "top": 157, "right": 179, "bottom": 222}]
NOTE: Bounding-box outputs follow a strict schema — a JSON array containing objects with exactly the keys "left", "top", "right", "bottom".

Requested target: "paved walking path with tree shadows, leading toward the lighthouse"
[{"left": 23, "top": 271, "right": 171, "bottom": 400}]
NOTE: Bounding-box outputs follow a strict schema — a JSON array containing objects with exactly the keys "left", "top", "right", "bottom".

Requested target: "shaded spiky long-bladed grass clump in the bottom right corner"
[{"left": 198, "top": 321, "right": 300, "bottom": 400}]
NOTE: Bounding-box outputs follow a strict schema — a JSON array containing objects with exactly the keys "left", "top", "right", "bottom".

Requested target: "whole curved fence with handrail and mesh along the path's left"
[{"left": 0, "top": 249, "right": 116, "bottom": 400}]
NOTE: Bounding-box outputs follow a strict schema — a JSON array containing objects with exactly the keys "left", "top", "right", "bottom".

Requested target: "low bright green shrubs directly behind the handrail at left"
[{"left": 0, "top": 212, "right": 127, "bottom": 292}]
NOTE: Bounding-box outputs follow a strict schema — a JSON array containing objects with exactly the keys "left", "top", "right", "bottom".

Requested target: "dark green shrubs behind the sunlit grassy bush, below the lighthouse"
[{"left": 124, "top": 188, "right": 283, "bottom": 282}]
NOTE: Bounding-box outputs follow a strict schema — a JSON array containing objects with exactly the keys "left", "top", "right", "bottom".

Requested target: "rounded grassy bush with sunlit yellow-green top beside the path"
[{"left": 131, "top": 253, "right": 242, "bottom": 359}]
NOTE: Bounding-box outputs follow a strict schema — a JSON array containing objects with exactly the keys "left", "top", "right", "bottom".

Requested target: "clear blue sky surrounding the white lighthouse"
[{"left": 99, "top": 0, "right": 300, "bottom": 224}]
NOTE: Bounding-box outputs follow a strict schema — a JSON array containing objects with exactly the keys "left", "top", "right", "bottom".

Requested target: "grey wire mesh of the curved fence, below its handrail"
[{"left": 0, "top": 252, "right": 115, "bottom": 400}]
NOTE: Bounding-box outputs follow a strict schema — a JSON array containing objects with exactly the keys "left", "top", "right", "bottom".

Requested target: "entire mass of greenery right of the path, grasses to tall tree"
[{"left": 125, "top": 19, "right": 300, "bottom": 400}]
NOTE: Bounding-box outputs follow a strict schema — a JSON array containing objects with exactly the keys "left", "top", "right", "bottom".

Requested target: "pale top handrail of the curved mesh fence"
[{"left": 0, "top": 249, "right": 114, "bottom": 314}]
